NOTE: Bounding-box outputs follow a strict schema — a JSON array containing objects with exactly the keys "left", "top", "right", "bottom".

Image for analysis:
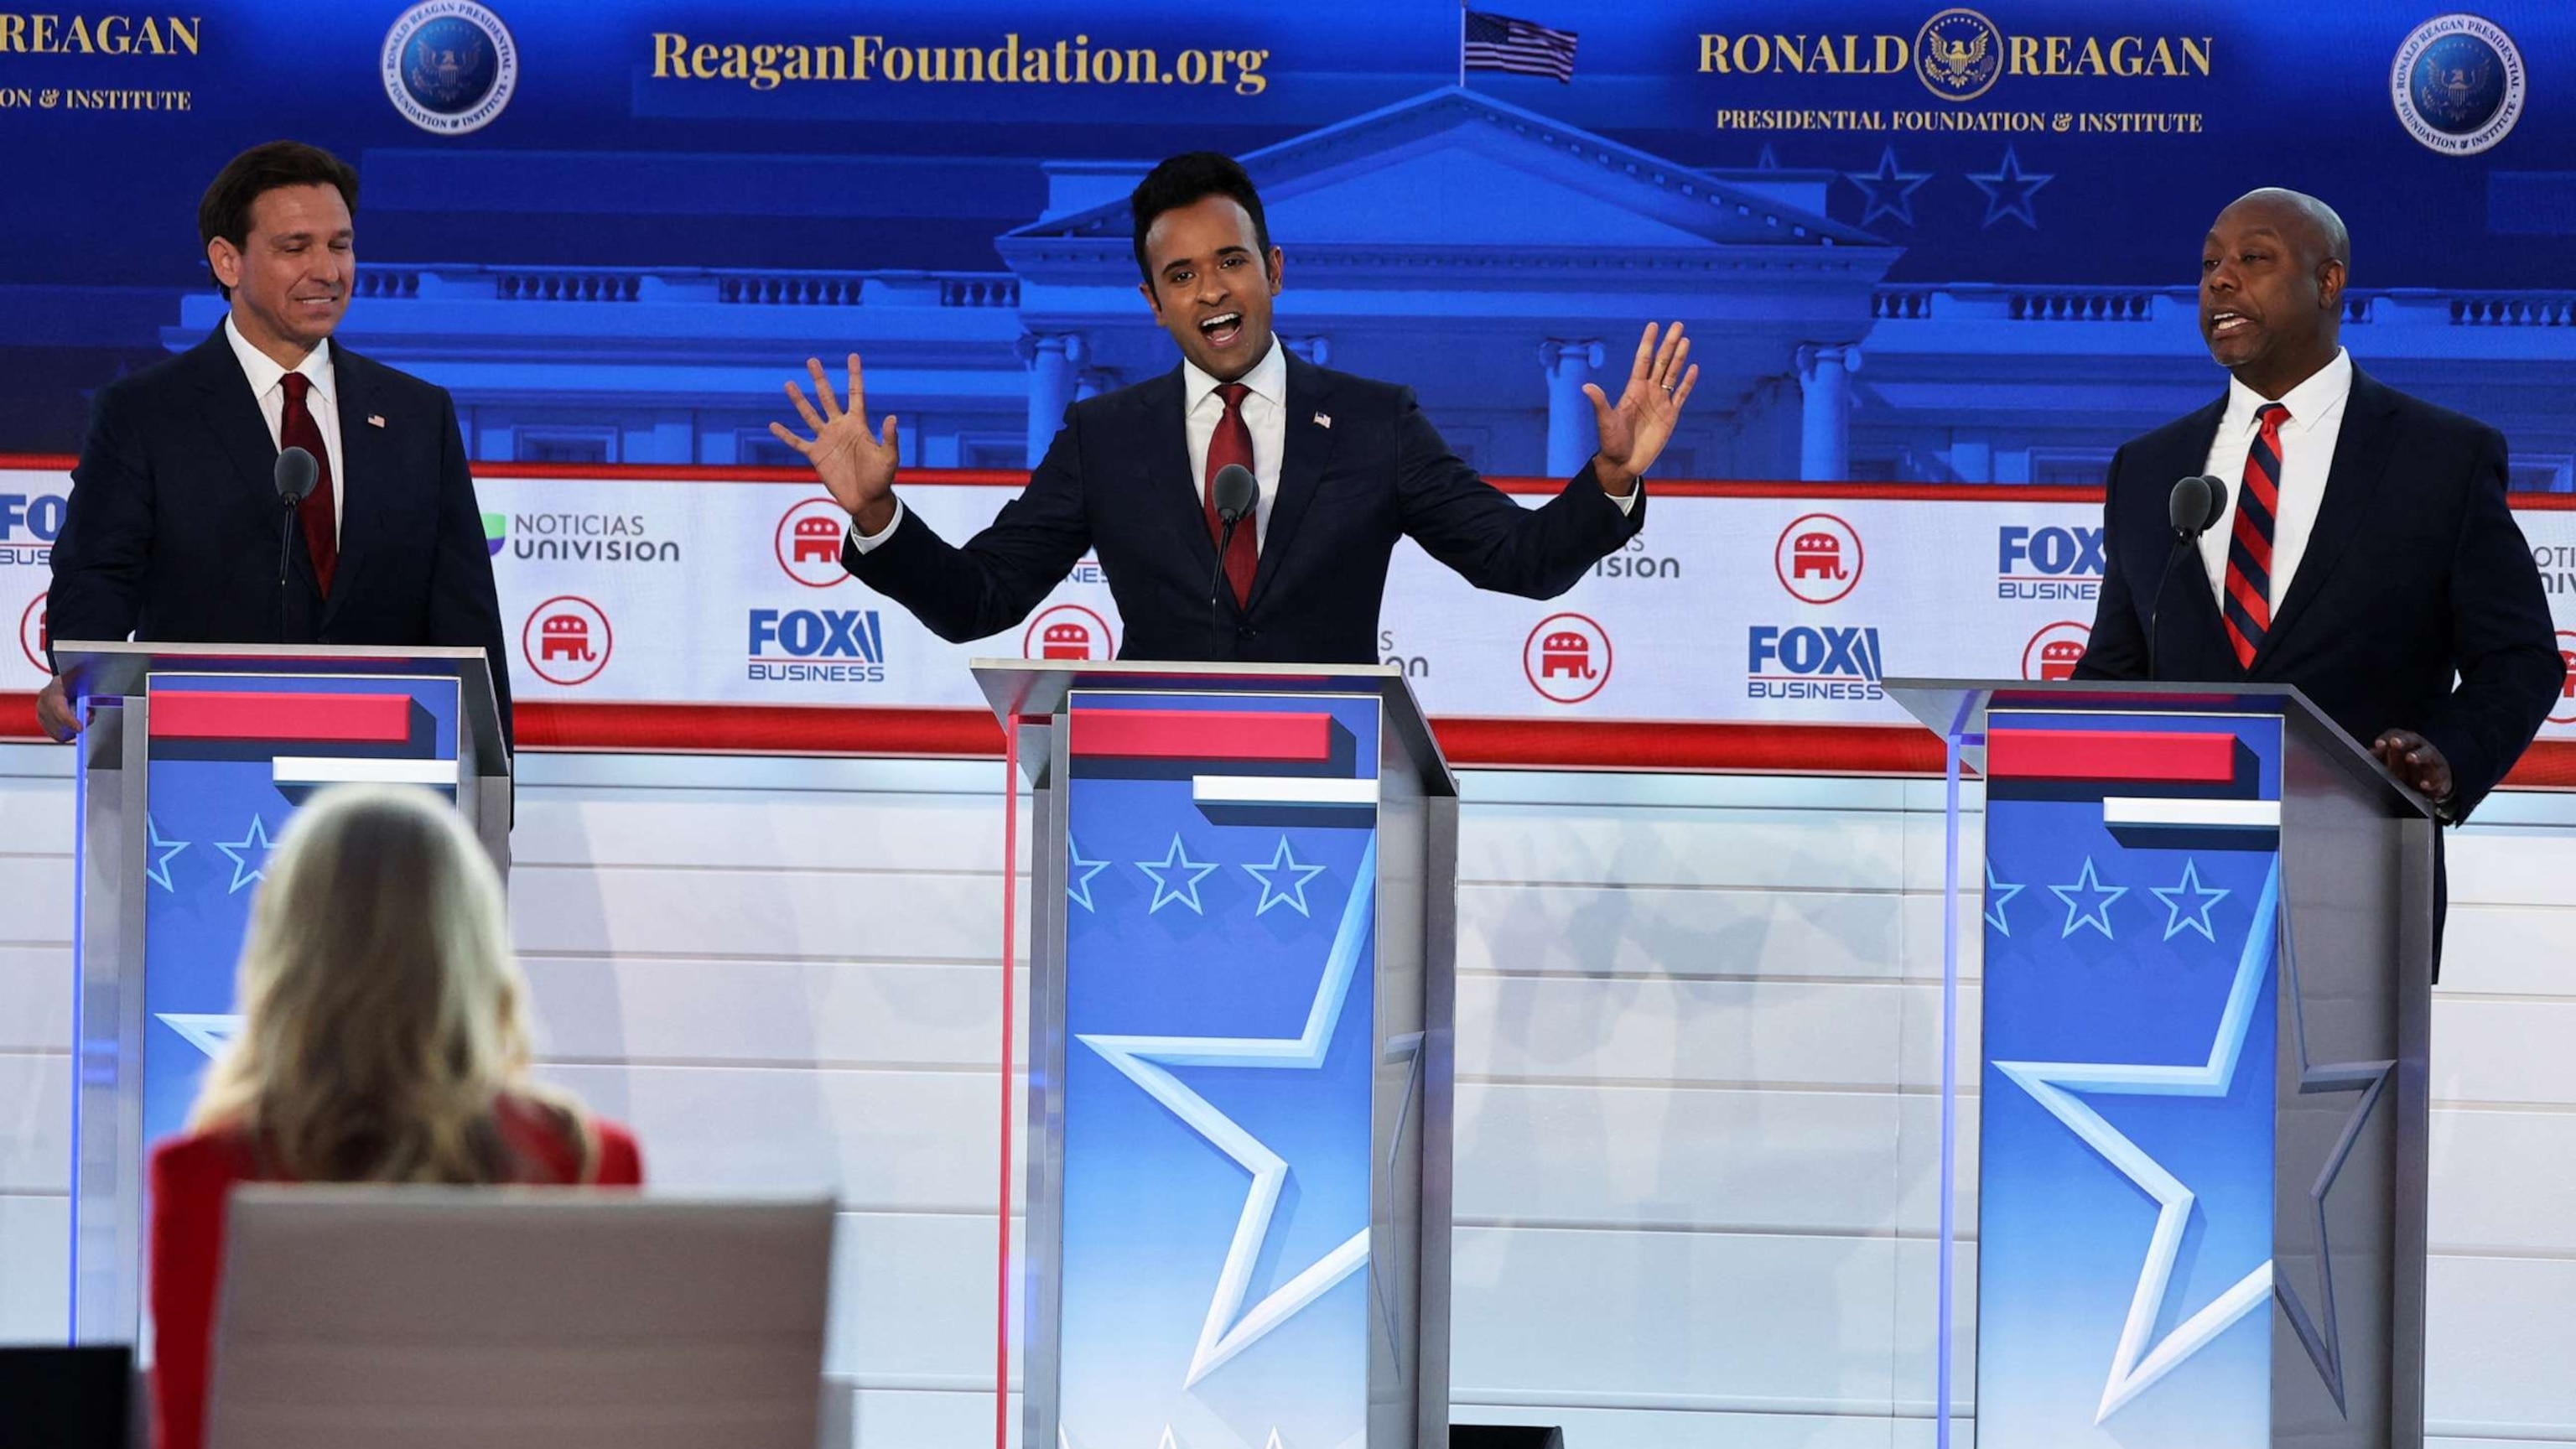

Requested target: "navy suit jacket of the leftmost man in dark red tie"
[{"left": 46, "top": 327, "right": 510, "bottom": 732}]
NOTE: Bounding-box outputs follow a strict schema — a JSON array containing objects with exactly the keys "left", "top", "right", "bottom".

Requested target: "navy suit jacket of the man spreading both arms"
[{"left": 843, "top": 356, "right": 1646, "bottom": 662}]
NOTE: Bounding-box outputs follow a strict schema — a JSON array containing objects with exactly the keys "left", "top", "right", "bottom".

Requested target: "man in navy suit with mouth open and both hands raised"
[{"left": 771, "top": 152, "right": 1697, "bottom": 662}]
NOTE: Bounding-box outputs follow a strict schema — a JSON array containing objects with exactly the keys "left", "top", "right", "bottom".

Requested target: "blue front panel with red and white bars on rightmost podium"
[{"left": 1976, "top": 709, "right": 2285, "bottom": 1449}]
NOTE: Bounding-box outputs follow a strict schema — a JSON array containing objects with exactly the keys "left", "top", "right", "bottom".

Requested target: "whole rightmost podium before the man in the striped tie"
[{"left": 1886, "top": 681, "right": 2434, "bottom": 1449}]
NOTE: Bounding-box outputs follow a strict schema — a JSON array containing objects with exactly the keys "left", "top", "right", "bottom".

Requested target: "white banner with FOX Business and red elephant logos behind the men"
[{"left": 0, "top": 470, "right": 2576, "bottom": 737}]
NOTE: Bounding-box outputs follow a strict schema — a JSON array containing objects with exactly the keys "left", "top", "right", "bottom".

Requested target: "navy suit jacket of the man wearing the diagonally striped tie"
[{"left": 2076, "top": 369, "right": 2566, "bottom": 820}]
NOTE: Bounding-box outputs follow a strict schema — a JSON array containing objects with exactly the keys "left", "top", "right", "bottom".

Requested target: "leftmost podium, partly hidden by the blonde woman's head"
[{"left": 55, "top": 642, "right": 510, "bottom": 1343}]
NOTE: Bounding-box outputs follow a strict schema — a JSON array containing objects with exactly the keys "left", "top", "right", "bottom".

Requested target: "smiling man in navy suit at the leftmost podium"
[{"left": 36, "top": 142, "right": 510, "bottom": 740}]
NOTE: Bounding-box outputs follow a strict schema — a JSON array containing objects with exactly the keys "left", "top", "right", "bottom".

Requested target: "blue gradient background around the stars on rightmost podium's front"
[{"left": 1976, "top": 714, "right": 2280, "bottom": 1449}]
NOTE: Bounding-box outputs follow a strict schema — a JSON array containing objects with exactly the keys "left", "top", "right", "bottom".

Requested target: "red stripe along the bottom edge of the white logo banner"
[{"left": 0, "top": 691, "right": 2576, "bottom": 789}]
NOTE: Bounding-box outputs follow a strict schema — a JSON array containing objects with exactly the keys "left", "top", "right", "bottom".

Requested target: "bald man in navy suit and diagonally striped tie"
[{"left": 2076, "top": 188, "right": 2566, "bottom": 943}]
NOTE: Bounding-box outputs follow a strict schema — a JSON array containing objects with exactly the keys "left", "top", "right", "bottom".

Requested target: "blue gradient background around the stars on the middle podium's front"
[{"left": 1059, "top": 693, "right": 1379, "bottom": 1449}]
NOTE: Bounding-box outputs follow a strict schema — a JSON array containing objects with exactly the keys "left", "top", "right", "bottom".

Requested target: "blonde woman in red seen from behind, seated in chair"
[{"left": 152, "top": 787, "right": 644, "bottom": 1449}]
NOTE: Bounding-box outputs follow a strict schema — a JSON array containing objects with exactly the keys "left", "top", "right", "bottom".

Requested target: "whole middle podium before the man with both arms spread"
[{"left": 974, "top": 660, "right": 1458, "bottom": 1449}]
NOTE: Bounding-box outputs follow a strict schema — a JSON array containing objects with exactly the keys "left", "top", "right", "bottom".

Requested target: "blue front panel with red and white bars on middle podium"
[{"left": 1057, "top": 691, "right": 1394, "bottom": 1449}]
